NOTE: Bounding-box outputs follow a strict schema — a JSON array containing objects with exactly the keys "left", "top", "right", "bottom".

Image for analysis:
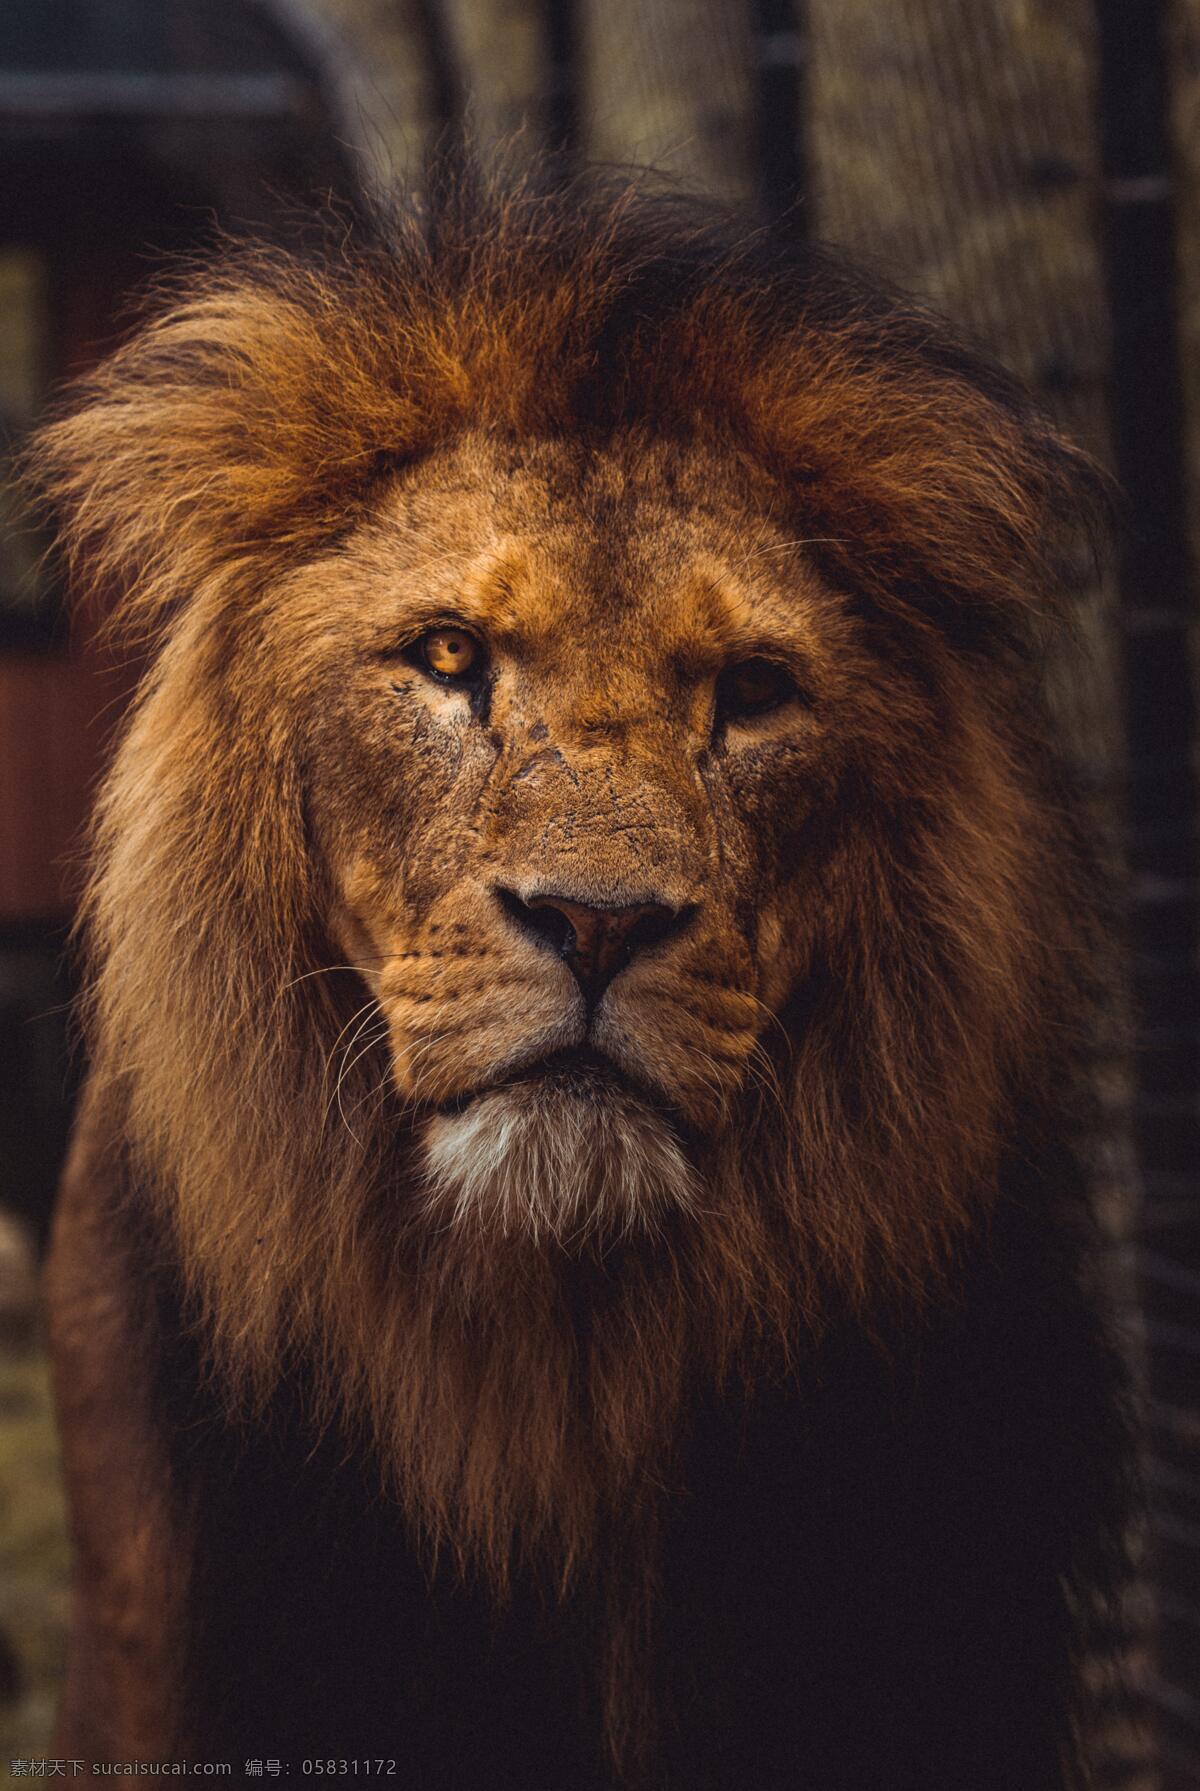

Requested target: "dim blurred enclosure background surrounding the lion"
[{"left": 0, "top": 0, "right": 1200, "bottom": 1791}]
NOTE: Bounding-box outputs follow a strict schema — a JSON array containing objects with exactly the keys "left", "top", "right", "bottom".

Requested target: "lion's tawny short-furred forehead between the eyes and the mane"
[{"left": 343, "top": 439, "right": 829, "bottom": 682}]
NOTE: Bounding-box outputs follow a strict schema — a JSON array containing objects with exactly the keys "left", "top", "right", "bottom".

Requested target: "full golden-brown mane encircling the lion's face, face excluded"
[{"left": 23, "top": 183, "right": 1124, "bottom": 1769}]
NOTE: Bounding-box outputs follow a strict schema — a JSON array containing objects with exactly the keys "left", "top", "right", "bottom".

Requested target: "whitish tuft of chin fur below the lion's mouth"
[{"left": 424, "top": 1082, "right": 697, "bottom": 1243}]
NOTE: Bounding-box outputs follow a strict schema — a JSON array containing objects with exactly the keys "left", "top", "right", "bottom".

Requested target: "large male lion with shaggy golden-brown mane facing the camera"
[{"left": 34, "top": 179, "right": 1127, "bottom": 1791}]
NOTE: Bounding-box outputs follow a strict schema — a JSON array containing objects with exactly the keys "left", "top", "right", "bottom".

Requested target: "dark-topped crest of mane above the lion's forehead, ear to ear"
[{"left": 32, "top": 171, "right": 1103, "bottom": 648}]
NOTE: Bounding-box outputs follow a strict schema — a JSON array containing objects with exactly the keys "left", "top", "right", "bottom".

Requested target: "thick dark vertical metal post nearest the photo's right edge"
[{"left": 1096, "top": 0, "right": 1200, "bottom": 1791}]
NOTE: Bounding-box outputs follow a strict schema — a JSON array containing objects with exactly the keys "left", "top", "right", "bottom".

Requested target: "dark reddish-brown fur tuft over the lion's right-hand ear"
[{"left": 677, "top": 279, "right": 1114, "bottom": 636}]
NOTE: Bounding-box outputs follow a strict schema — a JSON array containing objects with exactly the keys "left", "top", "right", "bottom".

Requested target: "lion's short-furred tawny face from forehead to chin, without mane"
[{"left": 295, "top": 441, "right": 866, "bottom": 1230}]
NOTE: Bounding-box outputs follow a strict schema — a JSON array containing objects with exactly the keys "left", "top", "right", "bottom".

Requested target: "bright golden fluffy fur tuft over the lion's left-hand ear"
[{"left": 23, "top": 253, "right": 433, "bottom": 648}]
